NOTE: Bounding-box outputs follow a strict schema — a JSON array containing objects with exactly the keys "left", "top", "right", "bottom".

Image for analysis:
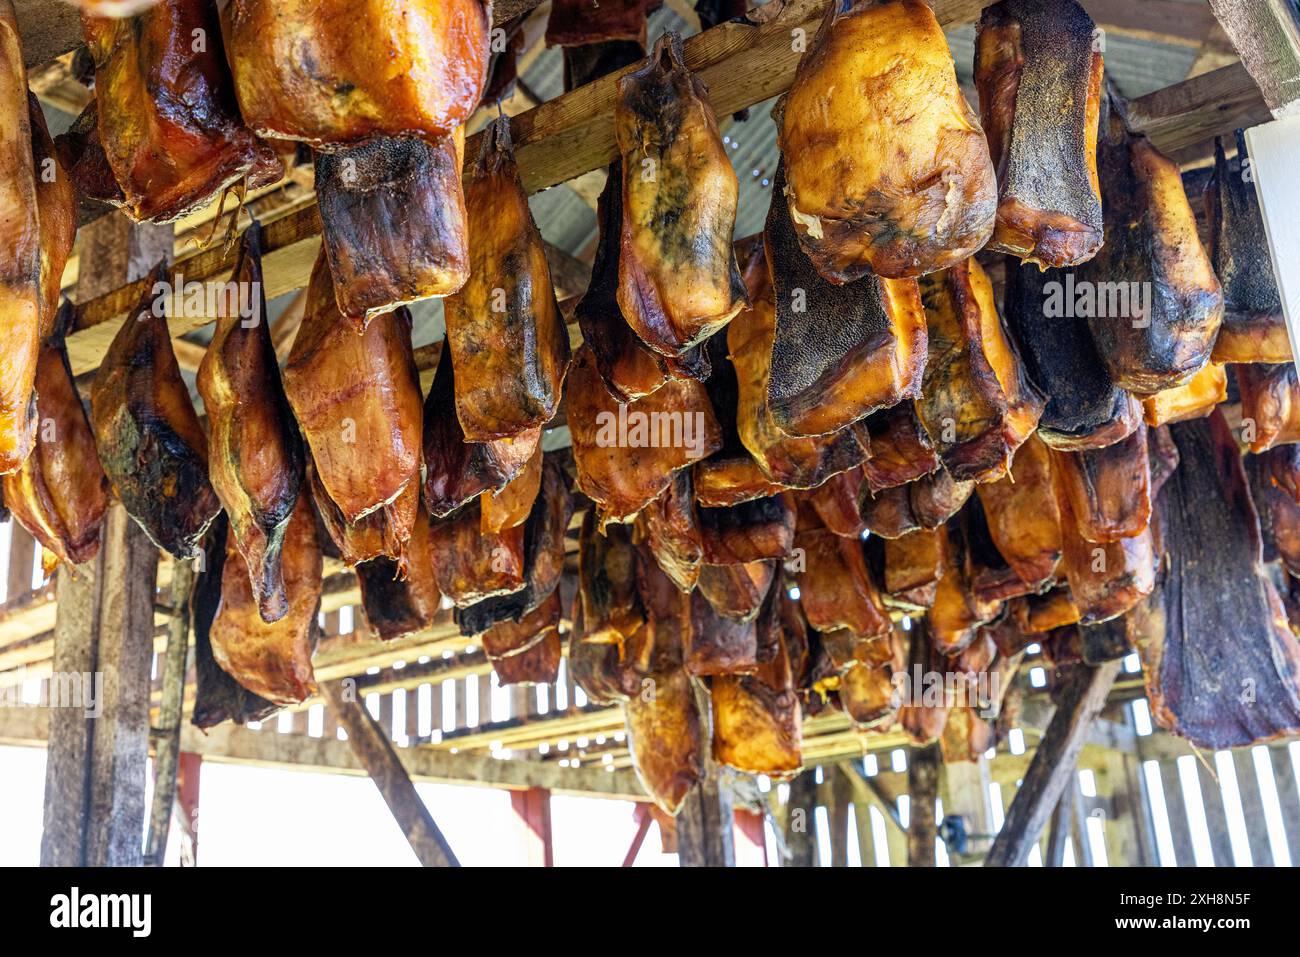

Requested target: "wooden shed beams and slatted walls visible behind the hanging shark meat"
[{"left": 0, "top": 0, "right": 1300, "bottom": 866}]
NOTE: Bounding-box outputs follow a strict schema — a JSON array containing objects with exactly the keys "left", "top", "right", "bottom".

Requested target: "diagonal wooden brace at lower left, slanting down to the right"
[{"left": 321, "top": 681, "right": 460, "bottom": 867}]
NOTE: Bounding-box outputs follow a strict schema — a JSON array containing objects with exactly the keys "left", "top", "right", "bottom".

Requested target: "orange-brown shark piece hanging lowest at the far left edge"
[{"left": 4, "top": 310, "right": 108, "bottom": 573}]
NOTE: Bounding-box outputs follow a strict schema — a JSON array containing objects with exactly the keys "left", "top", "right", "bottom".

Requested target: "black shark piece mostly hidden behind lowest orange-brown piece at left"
[{"left": 190, "top": 515, "right": 280, "bottom": 729}]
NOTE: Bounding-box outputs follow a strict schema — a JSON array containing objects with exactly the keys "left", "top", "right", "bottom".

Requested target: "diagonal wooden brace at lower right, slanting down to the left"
[{"left": 977, "top": 661, "right": 1122, "bottom": 867}]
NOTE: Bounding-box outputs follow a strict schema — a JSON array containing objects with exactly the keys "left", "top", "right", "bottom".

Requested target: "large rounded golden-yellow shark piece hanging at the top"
[{"left": 774, "top": 0, "right": 997, "bottom": 283}]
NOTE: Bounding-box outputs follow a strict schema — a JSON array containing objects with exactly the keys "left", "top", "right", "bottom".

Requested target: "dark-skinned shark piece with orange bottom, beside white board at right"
[{"left": 1205, "top": 130, "right": 1291, "bottom": 363}]
